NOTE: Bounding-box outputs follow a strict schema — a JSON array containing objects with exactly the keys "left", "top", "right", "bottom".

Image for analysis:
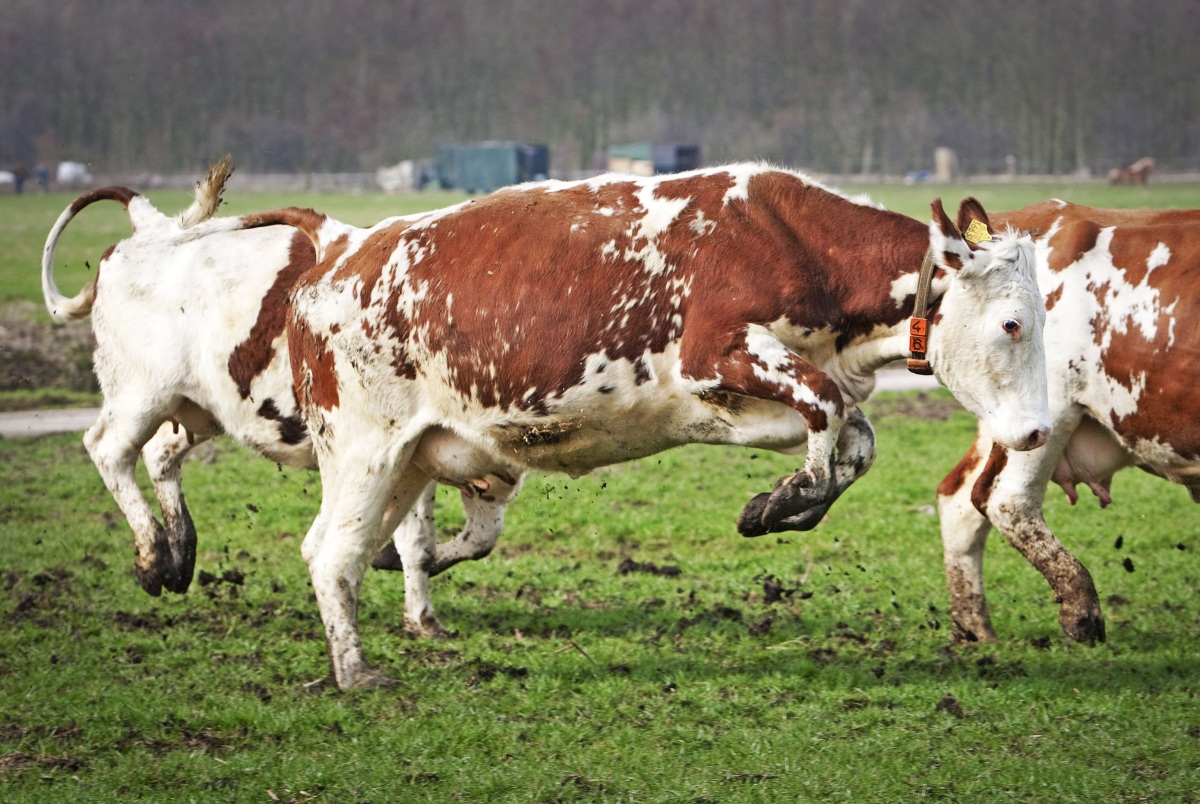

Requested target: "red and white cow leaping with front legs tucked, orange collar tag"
[{"left": 204, "top": 164, "right": 1049, "bottom": 686}]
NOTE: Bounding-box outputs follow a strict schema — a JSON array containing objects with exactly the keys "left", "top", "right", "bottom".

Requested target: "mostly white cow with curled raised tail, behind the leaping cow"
[{"left": 42, "top": 161, "right": 504, "bottom": 635}]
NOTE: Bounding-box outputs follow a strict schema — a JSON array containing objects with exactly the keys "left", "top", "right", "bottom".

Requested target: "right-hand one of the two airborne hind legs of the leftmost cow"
[{"left": 142, "top": 421, "right": 210, "bottom": 594}]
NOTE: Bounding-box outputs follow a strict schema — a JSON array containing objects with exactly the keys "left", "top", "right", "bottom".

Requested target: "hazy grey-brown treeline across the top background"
[{"left": 0, "top": 0, "right": 1200, "bottom": 174}]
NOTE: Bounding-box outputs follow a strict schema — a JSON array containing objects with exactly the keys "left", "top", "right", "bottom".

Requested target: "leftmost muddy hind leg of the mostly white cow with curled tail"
[{"left": 83, "top": 401, "right": 175, "bottom": 596}]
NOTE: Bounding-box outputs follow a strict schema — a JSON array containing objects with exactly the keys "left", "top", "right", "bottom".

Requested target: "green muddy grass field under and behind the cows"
[{"left": 0, "top": 185, "right": 1200, "bottom": 802}]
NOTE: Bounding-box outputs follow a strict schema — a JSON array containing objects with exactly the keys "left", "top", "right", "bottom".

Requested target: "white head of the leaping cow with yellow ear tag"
[{"left": 928, "top": 198, "right": 1050, "bottom": 450}]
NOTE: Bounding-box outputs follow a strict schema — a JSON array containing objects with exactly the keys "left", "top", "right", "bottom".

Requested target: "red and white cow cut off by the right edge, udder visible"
[{"left": 937, "top": 200, "right": 1200, "bottom": 641}]
